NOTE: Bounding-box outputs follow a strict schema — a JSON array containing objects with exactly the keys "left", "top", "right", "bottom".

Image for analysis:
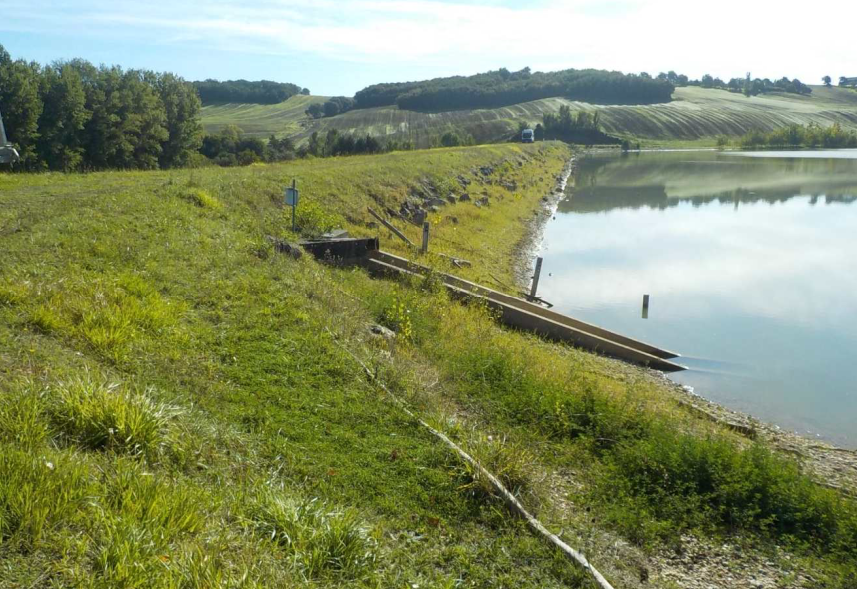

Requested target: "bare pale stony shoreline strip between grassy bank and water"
[{"left": 512, "top": 150, "right": 857, "bottom": 497}]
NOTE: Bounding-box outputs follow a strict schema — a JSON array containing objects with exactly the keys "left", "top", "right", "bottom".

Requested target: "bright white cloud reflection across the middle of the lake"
[{"left": 542, "top": 198, "right": 857, "bottom": 326}]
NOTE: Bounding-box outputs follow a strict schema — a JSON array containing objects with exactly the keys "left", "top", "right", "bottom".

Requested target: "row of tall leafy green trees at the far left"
[{"left": 0, "top": 46, "right": 202, "bottom": 171}]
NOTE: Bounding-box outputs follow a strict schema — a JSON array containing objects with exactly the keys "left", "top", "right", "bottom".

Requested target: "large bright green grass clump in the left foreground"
[{"left": 48, "top": 378, "right": 176, "bottom": 457}]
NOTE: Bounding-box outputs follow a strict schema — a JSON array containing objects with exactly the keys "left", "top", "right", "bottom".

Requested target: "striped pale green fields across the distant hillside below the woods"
[{"left": 203, "top": 86, "right": 857, "bottom": 147}]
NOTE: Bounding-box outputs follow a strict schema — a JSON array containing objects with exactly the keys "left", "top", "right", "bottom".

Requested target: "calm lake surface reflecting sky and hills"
[{"left": 539, "top": 150, "right": 857, "bottom": 447}]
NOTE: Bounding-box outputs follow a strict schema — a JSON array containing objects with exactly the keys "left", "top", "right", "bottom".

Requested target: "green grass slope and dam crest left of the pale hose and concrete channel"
[{"left": 0, "top": 147, "right": 592, "bottom": 587}]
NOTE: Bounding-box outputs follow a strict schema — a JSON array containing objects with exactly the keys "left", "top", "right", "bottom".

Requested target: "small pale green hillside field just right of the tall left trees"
[{"left": 201, "top": 94, "right": 327, "bottom": 139}]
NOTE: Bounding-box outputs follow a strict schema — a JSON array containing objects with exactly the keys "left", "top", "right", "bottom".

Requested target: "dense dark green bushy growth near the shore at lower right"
[{"left": 600, "top": 424, "right": 857, "bottom": 559}]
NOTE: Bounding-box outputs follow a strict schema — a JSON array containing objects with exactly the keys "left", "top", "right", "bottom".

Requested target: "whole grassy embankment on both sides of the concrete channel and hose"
[{"left": 0, "top": 145, "right": 857, "bottom": 587}]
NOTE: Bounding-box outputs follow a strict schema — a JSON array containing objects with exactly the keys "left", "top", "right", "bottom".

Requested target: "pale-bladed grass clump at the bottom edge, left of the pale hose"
[{"left": 242, "top": 491, "right": 375, "bottom": 579}]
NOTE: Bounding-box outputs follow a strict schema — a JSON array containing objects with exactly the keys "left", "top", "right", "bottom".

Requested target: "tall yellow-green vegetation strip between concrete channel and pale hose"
[{"left": 376, "top": 276, "right": 857, "bottom": 560}]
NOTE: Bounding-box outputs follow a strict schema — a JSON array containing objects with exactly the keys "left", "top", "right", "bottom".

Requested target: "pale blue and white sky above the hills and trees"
[{"left": 0, "top": 0, "right": 857, "bottom": 96}]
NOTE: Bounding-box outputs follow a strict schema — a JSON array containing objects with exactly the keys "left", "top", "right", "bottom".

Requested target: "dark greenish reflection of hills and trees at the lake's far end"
[{"left": 559, "top": 154, "right": 857, "bottom": 213}]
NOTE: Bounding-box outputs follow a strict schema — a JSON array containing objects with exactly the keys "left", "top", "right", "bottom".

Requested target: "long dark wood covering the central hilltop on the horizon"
[{"left": 354, "top": 68, "right": 673, "bottom": 111}]
